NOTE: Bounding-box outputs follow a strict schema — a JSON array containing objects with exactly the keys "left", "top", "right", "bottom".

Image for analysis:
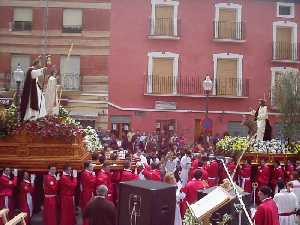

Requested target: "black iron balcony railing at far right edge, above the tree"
[{"left": 273, "top": 41, "right": 300, "bottom": 61}]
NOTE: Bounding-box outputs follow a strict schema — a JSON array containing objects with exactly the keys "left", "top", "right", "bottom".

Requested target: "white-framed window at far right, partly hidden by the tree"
[{"left": 271, "top": 67, "right": 299, "bottom": 108}]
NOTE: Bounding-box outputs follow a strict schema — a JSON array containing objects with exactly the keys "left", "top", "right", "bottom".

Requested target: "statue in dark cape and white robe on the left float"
[{"left": 20, "top": 59, "right": 47, "bottom": 121}]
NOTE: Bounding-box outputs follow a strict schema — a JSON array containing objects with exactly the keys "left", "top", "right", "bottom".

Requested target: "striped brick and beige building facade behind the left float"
[{"left": 0, "top": 0, "right": 111, "bottom": 128}]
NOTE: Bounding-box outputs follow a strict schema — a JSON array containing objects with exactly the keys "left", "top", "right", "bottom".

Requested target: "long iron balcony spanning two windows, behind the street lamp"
[{"left": 145, "top": 75, "right": 249, "bottom": 98}]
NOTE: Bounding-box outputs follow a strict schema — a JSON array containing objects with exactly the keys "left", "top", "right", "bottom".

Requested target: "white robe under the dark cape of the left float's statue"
[{"left": 24, "top": 69, "right": 47, "bottom": 120}]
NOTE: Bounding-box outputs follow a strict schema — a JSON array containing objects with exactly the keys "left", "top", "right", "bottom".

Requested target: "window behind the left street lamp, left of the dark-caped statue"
[{"left": 10, "top": 55, "right": 31, "bottom": 88}]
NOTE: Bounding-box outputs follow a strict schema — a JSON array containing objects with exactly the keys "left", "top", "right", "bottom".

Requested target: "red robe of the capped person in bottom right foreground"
[{"left": 254, "top": 198, "right": 279, "bottom": 225}]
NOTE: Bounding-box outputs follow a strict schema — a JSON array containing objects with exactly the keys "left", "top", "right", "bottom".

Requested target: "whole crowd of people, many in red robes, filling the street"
[{"left": 0, "top": 131, "right": 300, "bottom": 225}]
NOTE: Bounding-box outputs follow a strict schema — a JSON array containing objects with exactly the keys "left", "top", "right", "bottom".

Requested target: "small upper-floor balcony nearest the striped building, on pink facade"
[{"left": 149, "top": 18, "right": 179, "bottom": 40}]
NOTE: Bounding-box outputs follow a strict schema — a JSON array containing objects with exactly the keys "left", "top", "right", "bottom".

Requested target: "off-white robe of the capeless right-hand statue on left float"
[{"left": 45, "top": 76, "right": 59, "bottom": 115}]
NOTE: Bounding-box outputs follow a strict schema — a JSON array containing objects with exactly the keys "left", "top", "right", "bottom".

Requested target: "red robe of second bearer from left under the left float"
[{"left": 18, "top": 180, "right": 33, "bottom": 224}]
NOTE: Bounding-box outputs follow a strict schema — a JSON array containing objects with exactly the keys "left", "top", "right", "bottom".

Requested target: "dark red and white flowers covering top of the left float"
[{"left": 0, "top": 105, "right": 102, "bottom": 153}]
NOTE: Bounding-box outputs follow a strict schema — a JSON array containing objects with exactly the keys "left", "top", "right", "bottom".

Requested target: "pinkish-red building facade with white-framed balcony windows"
[{"left": 109, "top": 0, "right": 300, "bottom": 141}]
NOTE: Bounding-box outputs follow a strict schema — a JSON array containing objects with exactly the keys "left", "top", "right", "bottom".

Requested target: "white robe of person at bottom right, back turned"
[{"left": 273, "top": 190, "right": 298, "bottom": 225}]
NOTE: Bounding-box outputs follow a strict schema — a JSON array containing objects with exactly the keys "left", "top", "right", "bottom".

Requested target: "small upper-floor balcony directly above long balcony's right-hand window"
[{"left": 213, "top": 21, "right": 245, "bottom": 42}]
